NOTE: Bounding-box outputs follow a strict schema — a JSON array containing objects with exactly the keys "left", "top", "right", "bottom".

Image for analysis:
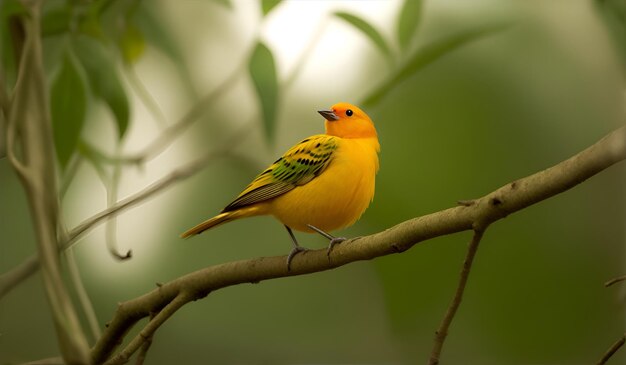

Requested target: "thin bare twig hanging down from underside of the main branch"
[{"left": 428, "top": 229, "right": 484, "bottom": 365}]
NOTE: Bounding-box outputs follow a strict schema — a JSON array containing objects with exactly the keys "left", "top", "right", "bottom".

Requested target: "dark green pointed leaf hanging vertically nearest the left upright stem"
[{"left": 50, "top": 54, "right": 87, "bottom": 168}]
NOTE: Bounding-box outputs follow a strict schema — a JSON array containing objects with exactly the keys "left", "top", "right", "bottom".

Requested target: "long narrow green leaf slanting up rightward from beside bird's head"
[{"left": 362, "top": 25, "right": 508, "bottom": 105}]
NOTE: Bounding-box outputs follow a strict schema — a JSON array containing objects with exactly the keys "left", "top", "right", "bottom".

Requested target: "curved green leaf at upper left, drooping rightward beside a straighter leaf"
[{"left": 73, "top": 36, "right": 130, "bottom": 139}]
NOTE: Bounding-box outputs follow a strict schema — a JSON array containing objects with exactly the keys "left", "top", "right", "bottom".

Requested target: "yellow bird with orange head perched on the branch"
[{"left": 180, "top": 102, "right": 380, "bottom": 270}]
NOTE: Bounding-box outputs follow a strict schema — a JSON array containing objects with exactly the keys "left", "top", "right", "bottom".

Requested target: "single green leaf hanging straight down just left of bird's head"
[{"left": 248, "top": 42, "right": 278, "bottom": 143}]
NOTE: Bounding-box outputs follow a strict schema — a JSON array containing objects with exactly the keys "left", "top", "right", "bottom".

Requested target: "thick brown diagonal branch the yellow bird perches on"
[{"left": 92, "top": 126, "right": 626, "bottom": 364}]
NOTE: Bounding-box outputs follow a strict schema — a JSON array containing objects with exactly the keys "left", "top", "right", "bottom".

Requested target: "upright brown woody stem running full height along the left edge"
[{"left": 9, "top": 2, "right": 89, "bottom": 364}]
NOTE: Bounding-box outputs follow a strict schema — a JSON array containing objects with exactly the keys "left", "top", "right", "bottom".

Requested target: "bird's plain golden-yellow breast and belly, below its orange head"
[{"left": 264, "top": 137, "right": 380, "bottom": 232}]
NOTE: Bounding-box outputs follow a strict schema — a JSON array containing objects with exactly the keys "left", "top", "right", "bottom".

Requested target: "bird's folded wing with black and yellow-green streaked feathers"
[{"left": 222, "top": 134, "right": 337, "bottom": 212}]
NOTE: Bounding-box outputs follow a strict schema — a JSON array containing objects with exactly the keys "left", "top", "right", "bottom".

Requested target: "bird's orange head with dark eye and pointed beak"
[{"left": 318, "top": 103, "right": 377, "bottom": 138}]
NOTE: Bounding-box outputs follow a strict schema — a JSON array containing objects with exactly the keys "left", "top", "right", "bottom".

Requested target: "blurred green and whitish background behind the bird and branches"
[{"left": 0, "top": 0, "right": 626, "bottom": 364}]
